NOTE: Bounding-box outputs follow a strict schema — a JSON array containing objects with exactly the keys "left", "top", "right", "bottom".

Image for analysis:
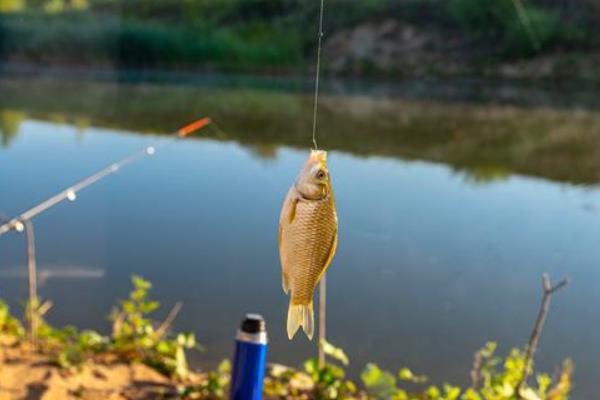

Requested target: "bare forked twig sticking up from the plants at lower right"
[{"left": 517, "top": 273, "right": 569, "bottom": 398}]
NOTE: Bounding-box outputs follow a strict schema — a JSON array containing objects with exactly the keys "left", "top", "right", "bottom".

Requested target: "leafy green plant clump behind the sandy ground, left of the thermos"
[{"left": 11, "top": 276, "right": 200, "bottom": 378}]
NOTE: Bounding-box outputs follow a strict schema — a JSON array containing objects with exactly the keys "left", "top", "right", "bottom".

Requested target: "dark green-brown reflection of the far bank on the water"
[{"left": 0, "top": 79, "right": 600, "bottom": 184}]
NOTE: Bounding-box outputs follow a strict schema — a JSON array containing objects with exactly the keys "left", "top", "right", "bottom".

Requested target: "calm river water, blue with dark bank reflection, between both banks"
[{"left": 0, "top": 75, "right": 600, "bottom": 398}]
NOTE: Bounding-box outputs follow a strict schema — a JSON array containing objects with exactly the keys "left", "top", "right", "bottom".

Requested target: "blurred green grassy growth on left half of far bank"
[{"left": 0, "top": 13, "right": 302, "bottom": 70}]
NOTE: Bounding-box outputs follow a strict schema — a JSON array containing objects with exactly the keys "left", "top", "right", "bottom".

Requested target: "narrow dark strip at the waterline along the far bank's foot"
[{"left": 0, "top": 62, "right": 600, "bottom": 109}]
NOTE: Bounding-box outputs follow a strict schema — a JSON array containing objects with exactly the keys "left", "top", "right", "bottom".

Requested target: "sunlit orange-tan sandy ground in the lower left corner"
[{"left": 0, "top": 337, "right": 195, "bottom": 400}]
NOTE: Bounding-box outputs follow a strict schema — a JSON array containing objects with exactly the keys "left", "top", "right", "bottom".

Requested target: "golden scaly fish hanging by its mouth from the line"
[{"left": 279, "top": 150, "right": 338, "bottom": 340}]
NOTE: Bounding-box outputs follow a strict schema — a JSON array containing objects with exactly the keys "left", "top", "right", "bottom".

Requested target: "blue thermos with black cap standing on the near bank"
[{"left": 230, "top": 314, "right": 267, "bottom": 400}]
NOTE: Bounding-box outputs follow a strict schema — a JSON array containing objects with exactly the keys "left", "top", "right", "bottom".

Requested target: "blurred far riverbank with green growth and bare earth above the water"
[{"left": 0, "top": 0, "right": 600, "bottom": 82}]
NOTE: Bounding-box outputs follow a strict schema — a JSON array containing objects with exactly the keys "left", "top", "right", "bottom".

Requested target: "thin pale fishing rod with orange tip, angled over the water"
[{"left": 0, "top": 117, "right": 212, "bottom": 236}]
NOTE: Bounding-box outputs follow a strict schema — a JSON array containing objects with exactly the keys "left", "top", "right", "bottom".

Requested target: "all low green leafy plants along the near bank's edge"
[{"left": 0, "top": 276, "right": 573, "bottom": 400}]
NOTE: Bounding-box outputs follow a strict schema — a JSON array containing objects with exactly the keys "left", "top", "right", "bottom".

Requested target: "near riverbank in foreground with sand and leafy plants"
[{"left": 0, "top": 276, "right": 573, "bottom": 400}]
